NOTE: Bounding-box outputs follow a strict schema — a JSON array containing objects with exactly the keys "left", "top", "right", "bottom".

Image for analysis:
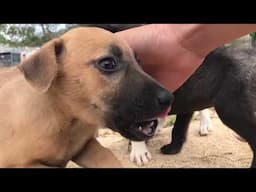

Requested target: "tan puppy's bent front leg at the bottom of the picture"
[{"left": 72, "top": 138, "right": 122, "bottom": 168}]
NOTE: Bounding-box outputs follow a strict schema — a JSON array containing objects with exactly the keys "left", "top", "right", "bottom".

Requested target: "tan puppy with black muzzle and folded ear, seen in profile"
[{"left": 0, "top": 28, "right": 173, "bottom": 167}]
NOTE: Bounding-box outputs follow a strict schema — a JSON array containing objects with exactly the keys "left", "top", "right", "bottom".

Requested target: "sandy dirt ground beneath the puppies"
[{"left": 68, "top": 111, "right": 252, "bottom": 168}]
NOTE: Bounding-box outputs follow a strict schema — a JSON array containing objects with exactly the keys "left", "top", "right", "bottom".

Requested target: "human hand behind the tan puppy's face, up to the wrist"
[{"left": 116, "top": 24, "right": 204, "bottom": 91}]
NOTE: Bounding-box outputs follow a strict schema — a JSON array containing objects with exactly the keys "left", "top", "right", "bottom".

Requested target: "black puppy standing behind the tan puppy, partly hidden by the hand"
[{"left": 89, "top": 24, "right": 256, "bottom": 167}]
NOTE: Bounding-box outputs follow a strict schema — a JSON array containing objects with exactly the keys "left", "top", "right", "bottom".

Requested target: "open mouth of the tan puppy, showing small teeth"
[{"left": 136, "top": 119, "right": 158, "bottom": 137}]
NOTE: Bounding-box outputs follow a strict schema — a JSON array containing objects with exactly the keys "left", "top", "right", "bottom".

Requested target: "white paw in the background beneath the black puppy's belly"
[{"left": 199, "top": 109, "right": 212, "bottom": 136}]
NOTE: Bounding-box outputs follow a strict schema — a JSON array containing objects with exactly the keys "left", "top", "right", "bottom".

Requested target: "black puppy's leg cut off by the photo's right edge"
[{"left": 215, "top": 94, "right": 256, "bottom": 168}]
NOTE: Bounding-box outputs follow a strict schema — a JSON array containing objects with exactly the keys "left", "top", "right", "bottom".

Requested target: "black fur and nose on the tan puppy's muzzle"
[{"left": 106, "top": 62, "right": 174, "bottom": 141}]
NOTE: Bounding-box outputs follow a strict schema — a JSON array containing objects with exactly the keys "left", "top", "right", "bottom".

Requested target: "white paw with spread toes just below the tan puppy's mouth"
[{"left": 130, "top": 141, "right": 152, "bottom": 166}]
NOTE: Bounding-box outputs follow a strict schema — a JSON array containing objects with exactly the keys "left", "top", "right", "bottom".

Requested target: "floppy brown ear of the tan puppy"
[{"left": 18, "top": 39, "right": 64, "bottom": 93}]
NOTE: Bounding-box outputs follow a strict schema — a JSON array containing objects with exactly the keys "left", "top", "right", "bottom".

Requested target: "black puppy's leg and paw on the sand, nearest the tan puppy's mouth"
[{"left": 161, "top": 112, "right": 193, "bottom": 154}]
